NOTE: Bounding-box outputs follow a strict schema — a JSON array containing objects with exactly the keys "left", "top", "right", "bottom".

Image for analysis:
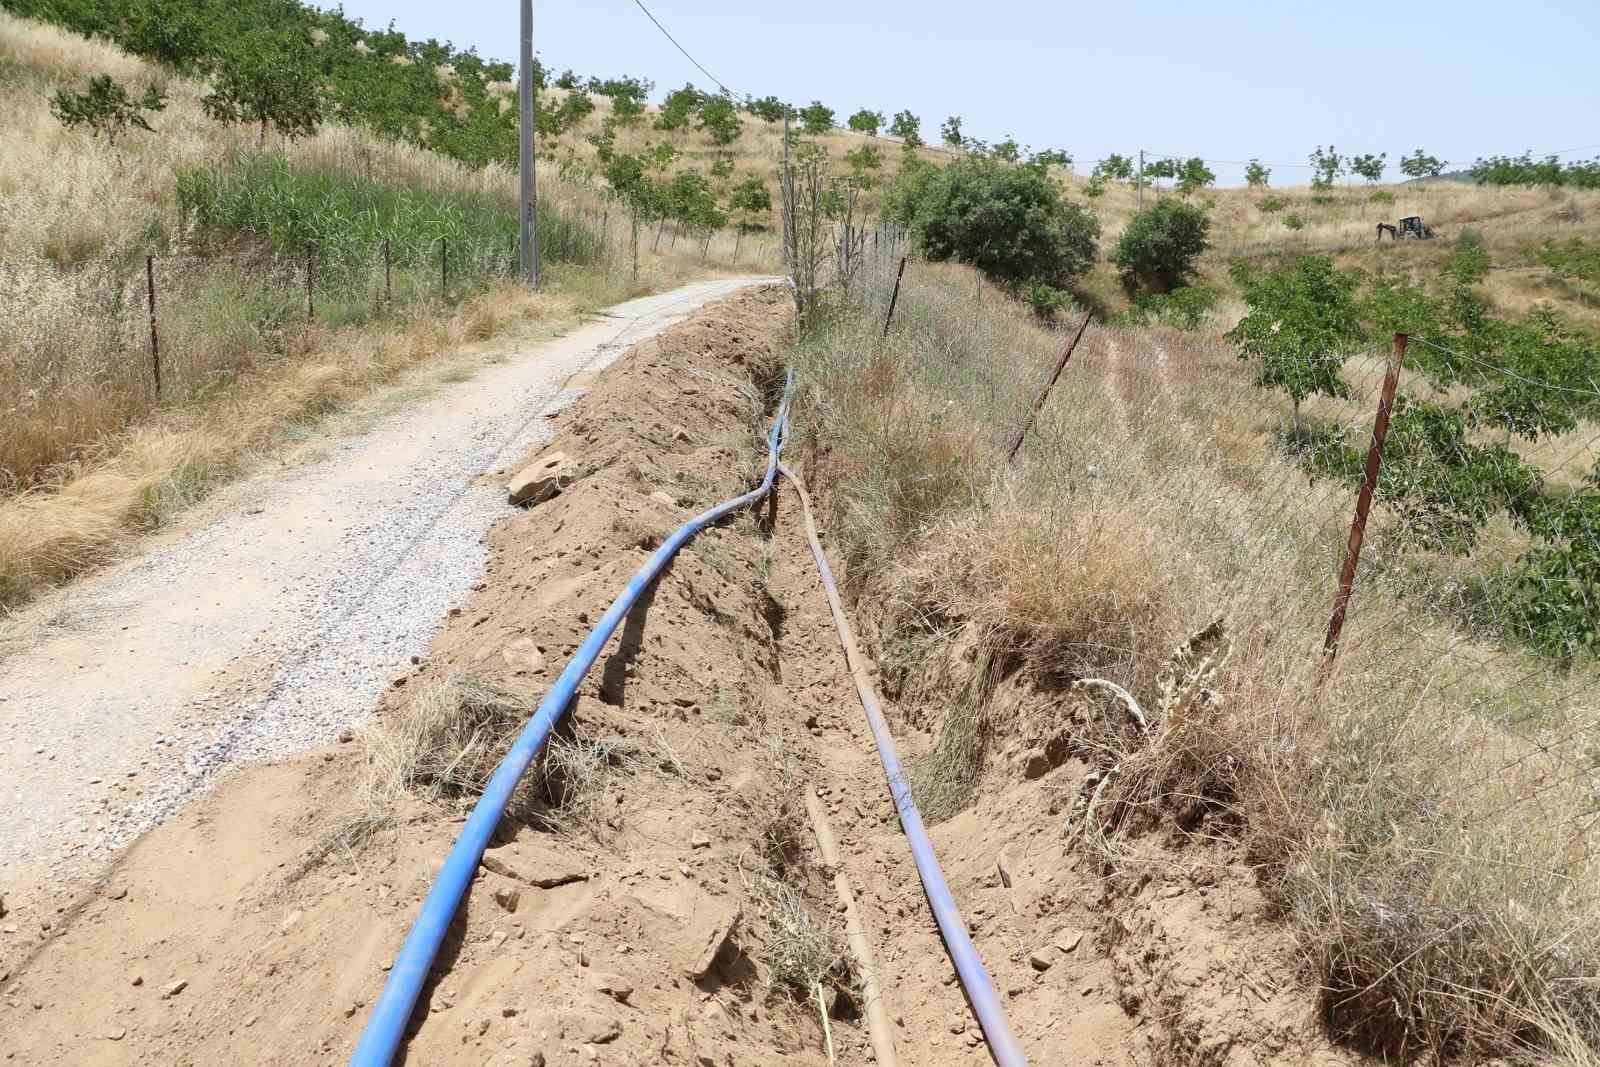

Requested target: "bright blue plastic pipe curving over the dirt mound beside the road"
[{"left": 350, "top": 373, "right": 794, "bottom": 1067}]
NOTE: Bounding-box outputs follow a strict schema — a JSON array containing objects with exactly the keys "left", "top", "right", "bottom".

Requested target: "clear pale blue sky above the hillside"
[{"left": 328, "top": 0, "right": 1600, "bottom": 184}]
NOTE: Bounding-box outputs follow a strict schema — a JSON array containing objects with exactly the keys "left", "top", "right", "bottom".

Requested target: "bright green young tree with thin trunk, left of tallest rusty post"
[{"left": 1227, "top": 256, "right": 1366, "bottom": 435}]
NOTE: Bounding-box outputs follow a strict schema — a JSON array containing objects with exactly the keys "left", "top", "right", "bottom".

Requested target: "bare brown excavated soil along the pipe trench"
[{"left": 0, "top": 288, "right": 1350, "bottom": 1067}]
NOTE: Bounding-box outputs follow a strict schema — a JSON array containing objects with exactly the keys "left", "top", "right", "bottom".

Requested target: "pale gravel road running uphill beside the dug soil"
[{"left": 0, "top": 278, "right": 774, "bottom": 893}]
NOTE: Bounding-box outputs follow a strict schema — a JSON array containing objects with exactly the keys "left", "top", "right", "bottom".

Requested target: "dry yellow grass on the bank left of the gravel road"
[{"left": 0, "top": 11, "right": 774, "bottom": 608}]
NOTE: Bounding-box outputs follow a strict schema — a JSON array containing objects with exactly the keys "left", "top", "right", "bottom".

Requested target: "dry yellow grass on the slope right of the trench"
[{"left": 797, "top": 255, "right": 1600, "bottom": 1062}]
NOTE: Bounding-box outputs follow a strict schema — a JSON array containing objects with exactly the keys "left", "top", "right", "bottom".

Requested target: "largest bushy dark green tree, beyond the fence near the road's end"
[{"left": 886, "top": 157, "right": 1099, "bottom": 286}]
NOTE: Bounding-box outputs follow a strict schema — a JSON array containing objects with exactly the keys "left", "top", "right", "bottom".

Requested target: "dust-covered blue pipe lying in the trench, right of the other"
[{"left": 779, "top": 466, "right": 1027, "bottom": 1067}]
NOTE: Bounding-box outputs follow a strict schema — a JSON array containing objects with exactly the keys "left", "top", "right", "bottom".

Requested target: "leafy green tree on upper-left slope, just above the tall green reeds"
[{"left": 200, "top": 30, "right": 323, "bottom": 146}]
